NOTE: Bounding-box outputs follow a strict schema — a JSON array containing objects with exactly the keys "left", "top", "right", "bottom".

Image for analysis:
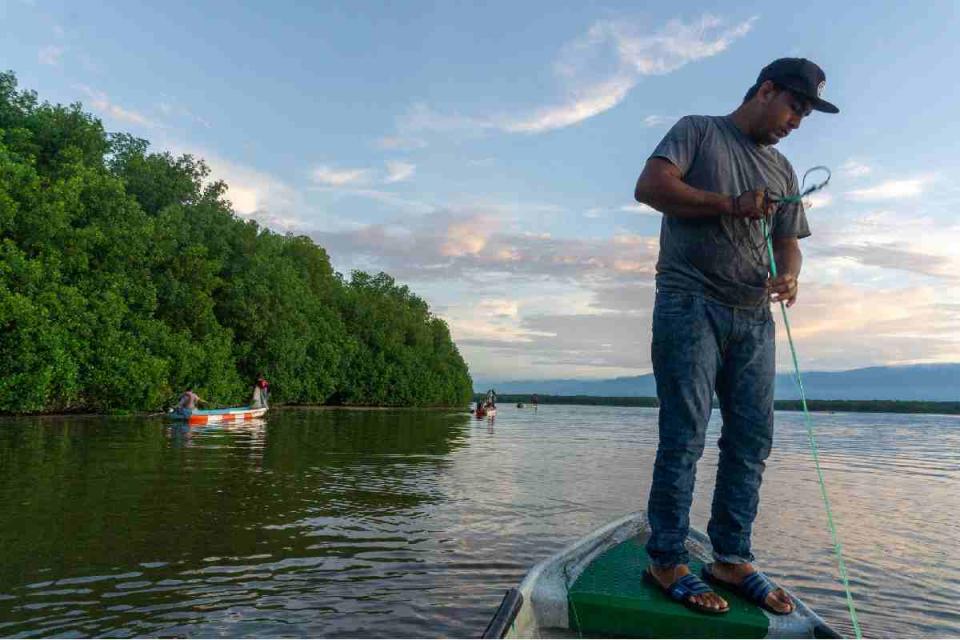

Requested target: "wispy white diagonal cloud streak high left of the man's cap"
[{"left": 398, "top": 15, "right": 756, "bottom": 134}]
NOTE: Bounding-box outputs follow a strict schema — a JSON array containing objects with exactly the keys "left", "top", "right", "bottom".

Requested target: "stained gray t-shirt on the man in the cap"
[{"left": 651, "top": 116, "right": 810, "bottom": 308}]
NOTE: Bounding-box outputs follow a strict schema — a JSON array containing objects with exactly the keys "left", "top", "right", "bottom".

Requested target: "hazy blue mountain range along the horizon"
[{"left": 473, "top": 364, "right": 960, "bottom": 402}]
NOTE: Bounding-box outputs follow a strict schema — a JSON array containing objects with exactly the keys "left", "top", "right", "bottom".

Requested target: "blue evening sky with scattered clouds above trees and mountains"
[{"left": 0, "top": 0, "right": 960, "bottom": 380}]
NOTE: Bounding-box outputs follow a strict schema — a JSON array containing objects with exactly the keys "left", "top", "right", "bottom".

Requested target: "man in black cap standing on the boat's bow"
[{"left": 635, "top": 58, "right": 839, "bottom": 614}]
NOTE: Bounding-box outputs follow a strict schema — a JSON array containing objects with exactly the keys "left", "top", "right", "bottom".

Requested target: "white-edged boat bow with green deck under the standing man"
[{"left": 482, "top": 512, "right": 842, "bottom": 638}]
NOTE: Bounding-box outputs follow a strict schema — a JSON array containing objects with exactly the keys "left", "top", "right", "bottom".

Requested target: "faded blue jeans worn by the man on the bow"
[{"left": 647, "top": 291, "right": 776, "bottom": 567}]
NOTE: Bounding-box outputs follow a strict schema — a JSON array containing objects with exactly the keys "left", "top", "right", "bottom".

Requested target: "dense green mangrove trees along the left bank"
[{"left": 0, "top": 72, "right": 472, "bottom": 413}]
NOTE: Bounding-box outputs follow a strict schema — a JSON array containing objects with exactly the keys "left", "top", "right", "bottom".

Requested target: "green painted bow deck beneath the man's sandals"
[{"left": 568, "top": 538, "right": 768, "bottom": 638}]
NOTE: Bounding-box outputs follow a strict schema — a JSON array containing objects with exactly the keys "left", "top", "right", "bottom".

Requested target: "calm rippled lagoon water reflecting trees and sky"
[{"left": 0, "top": 406, "right": 960, "bottom": 637}]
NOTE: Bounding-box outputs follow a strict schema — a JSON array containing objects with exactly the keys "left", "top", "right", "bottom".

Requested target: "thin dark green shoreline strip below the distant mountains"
[{"left": 488, "top": 393, "right": 960, "bottom": 415}]
